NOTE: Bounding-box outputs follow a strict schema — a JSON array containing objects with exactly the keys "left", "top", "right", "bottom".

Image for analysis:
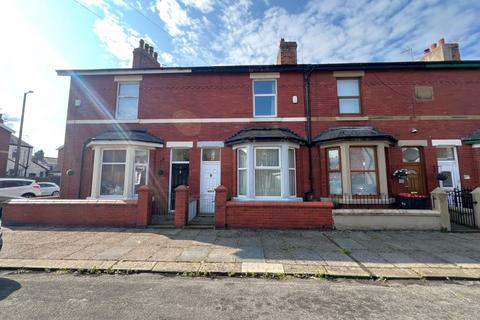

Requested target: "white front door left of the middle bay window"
[{"left": 200, "top": 149, "right": 220, "bottom": 215}]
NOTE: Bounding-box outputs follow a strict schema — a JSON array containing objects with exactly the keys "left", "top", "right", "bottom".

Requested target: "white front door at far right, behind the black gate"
[{"left": 437, "top": 147, "right": 460, "bottom": 190}]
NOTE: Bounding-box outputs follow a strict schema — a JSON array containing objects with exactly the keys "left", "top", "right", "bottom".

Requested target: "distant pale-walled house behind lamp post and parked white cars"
[{"left": 5, "top": 135, "right": 49, "bottom": 178}]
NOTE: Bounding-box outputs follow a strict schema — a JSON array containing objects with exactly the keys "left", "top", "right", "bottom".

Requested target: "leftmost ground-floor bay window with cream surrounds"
[{"left": 91, "top": 145, "right": 151, "bottom": 199}]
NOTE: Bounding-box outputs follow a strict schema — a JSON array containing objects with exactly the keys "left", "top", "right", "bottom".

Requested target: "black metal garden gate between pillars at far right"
[{"left": 448, "top": 189, "right": 476, "bottom": 228}]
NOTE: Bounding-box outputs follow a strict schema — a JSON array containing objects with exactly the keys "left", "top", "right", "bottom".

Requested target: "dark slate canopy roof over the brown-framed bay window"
[{"left": 313, "top": 126, "right": 397, "bottom": 143}]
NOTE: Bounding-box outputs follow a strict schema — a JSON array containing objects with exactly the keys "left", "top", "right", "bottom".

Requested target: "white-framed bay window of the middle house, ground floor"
[{"left": 236, "top": 143, "right": 300, "bottom": 200}]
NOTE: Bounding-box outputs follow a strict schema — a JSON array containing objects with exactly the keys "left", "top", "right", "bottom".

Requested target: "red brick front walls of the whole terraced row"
[{"left": 60, "top": 60, "right": 480, "bottom": 222}]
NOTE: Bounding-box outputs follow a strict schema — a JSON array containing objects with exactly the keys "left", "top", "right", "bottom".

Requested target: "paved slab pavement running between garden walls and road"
[{"left": 0, "top": 227, "right": 480, "bottom": 280}]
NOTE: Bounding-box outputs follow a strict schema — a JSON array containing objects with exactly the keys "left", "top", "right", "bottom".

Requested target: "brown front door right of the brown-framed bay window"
[{"left": 402, "top": 147, "right": 427, "bottom": 194}]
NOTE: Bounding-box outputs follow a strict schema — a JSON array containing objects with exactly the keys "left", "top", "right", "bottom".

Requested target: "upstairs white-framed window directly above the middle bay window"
[{"left": 253, "top": 80, "right": 277, "bottom": 117}]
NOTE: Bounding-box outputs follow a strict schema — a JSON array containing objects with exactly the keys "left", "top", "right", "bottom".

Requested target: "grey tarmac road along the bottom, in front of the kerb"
[{"left": 0, "top": 271, "right": 480, "bottom": 320}]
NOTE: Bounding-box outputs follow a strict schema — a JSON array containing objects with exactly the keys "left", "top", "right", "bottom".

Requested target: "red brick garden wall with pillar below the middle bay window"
[{"left": 215, "top": 186, "right": 333, "bottom": 229}]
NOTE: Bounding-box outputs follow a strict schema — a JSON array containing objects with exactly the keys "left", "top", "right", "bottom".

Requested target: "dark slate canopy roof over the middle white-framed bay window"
[{"left": 225, "top": 127, "right": 306, "bottom": 145}]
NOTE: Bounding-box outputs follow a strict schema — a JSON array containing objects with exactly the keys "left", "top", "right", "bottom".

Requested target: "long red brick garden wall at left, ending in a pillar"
[{"left": 2, "top": 187, "right": 151, "bottom": 227}]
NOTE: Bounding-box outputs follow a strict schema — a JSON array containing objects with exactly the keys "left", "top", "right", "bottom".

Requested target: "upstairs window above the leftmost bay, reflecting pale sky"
[{"left": 116, "top": 82, "right": 140, "bottom": 120}]
